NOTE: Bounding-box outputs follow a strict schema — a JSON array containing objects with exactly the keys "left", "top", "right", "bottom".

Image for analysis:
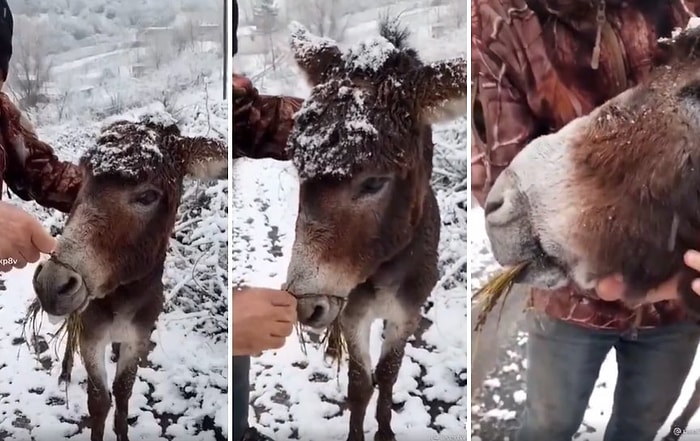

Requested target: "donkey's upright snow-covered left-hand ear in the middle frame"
[{"left": 289, "top": 21, "right": 343, "bottom": 86}]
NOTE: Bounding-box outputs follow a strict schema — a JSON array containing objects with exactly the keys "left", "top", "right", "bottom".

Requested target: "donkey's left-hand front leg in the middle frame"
[{"left": 341, "top": 314, "right": 374, "bottom": 441}]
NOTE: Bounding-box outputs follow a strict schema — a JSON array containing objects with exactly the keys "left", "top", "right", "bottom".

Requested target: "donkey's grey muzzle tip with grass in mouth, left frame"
[{"left": 32, "top": 259, "right": 88, "bottom": 317}]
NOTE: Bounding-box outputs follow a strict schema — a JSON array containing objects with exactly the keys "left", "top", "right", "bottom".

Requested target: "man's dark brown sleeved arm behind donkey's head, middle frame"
[{"left": 233, "top": 74, "right": 304, "bottom": 161}]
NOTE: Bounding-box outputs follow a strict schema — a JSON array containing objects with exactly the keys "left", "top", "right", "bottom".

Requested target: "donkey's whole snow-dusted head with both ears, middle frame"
[{"left": 287, "top": 19, "right": 467, "bottom": 327}]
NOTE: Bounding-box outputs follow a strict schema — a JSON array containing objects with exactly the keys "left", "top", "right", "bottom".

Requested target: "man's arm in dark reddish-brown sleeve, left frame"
[{"left": 0, "top": 94, "right": 82, "bottom": 213}]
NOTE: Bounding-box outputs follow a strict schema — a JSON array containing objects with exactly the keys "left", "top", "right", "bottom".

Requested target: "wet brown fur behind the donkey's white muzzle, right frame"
[{"left": 573, "top": 25, "right": 700, "bottom": 314}]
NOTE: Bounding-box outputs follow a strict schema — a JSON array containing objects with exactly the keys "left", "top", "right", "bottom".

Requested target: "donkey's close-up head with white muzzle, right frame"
[{"left": 485, "top": 24, "right": 700, "bottom": 313}]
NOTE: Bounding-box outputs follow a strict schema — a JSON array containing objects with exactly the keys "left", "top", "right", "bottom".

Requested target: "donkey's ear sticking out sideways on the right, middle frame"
[{"left": 410, "top": 58, "right": 468, "bottom": 124}]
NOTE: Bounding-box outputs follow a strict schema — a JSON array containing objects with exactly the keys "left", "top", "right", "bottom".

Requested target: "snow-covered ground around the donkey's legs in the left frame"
[{"left": 0, "top": 265, "right": 227, "bottom": 441}]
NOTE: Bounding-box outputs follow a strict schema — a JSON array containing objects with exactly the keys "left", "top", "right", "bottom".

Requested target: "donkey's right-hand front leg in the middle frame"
[{"left": 374, "top": 311, "right": 420, "bottom": 441}]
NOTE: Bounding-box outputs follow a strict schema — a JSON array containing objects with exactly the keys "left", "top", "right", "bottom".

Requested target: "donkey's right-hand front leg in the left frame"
[{"left": 112, "top": 333, "right": 150, "bottom": 441}]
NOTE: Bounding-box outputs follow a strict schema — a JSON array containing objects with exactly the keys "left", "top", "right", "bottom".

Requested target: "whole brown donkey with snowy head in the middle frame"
[{"left": 285, "top": 19, "right": 467, "bottom": 441}]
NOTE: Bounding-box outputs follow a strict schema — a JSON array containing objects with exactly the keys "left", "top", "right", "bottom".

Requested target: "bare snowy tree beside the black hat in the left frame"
[{"left": 9, "top": 16, "right": 51, "bottom": 108}]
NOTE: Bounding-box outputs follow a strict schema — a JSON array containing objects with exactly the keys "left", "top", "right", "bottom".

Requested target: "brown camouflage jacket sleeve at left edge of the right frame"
[{"left": 471, "top": 1, "right": 537, "bottom": 206}]
